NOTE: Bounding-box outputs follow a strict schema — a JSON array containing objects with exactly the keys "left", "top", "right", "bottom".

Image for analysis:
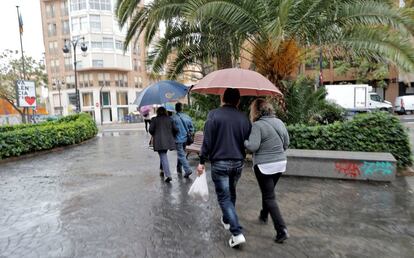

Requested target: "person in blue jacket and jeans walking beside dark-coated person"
[{"left": 172, "top": 102, "right": 194, "bottom": 178}]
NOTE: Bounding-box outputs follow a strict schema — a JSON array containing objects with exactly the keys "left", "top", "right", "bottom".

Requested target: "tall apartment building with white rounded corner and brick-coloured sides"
[{"left": 40, "top": 0, "right": 148, "bottom": 123}]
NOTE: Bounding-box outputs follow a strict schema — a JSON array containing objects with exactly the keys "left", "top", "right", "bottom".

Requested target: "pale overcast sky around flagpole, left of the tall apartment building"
[{"left": 0, "top": 0, "right": 45, "bottom": 60}]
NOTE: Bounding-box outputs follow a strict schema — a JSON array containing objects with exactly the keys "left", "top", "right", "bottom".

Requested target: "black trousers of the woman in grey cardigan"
[{"left": 254, "top": 165, "right": 286, "bottom": 232}]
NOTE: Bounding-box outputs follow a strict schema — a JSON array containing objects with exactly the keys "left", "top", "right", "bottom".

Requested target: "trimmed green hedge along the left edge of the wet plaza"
[{"left": 0, "top": 113, "right": 98, "bottom": 159}]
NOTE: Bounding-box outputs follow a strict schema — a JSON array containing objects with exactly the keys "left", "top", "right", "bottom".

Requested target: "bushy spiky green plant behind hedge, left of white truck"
[{"left": 275, "top": 78, "right": 345, "bottom": 125}]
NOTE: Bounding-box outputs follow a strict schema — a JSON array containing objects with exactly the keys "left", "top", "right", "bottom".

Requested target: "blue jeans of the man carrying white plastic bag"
[{"left": 211, "top": 160, "right": 243, "bottom": 236}]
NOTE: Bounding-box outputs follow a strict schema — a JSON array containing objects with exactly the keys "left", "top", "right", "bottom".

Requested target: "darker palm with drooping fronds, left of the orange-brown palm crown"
[{"left": 116, "top": 0, "right": 240, "bottom": 78}]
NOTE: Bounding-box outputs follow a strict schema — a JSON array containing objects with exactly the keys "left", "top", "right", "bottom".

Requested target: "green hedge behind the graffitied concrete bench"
[{"left": 288, "top": 112, "right": 412, "bottom": 167}]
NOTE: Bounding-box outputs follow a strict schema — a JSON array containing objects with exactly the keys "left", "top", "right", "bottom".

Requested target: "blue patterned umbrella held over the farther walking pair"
[{"left": 134, "top": 81, "right": 188, "bottom": 107}]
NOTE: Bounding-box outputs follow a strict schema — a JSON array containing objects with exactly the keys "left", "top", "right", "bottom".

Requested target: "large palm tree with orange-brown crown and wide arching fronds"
[{"left": 117, "top": 0, "right": 414, "bottom": 92}]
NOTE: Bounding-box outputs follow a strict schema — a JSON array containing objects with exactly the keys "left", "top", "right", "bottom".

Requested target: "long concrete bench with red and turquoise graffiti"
[{"left": 285, "top": 149, "right": 397, "bottom": 181}]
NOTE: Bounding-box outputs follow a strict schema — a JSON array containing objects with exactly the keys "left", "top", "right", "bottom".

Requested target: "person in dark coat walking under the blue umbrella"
[{"left": 149, "top": 107, "right": 178, "bottom": 183}]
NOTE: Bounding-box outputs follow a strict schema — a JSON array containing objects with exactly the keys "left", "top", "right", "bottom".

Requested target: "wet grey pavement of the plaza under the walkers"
[{"left": 0, "top": 127, "right": 414, "bottom": 257}]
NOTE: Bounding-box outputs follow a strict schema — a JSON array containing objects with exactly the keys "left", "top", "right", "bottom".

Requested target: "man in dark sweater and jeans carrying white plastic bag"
[{"left": 197, "top": 88, "right": 251, "bottom": 247}]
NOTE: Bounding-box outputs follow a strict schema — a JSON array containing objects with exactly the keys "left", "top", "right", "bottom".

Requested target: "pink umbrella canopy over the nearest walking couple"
[{"left": 191, "top": 68, "right": 283, "bottom": 96}]
